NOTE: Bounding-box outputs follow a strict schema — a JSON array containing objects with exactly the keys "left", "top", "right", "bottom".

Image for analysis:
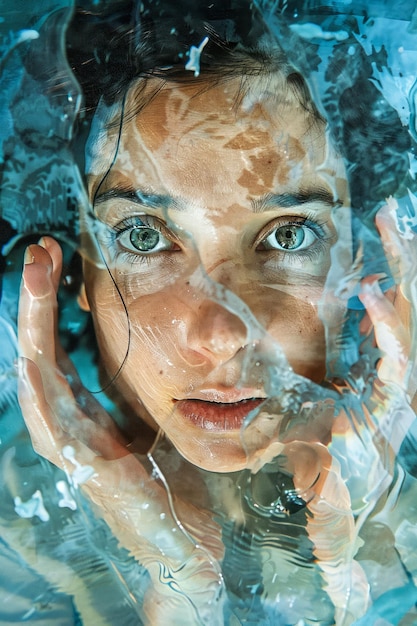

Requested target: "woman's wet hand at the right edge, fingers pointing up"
[{"left": 359, "top": 207, "right": 417, "bottom": 446}]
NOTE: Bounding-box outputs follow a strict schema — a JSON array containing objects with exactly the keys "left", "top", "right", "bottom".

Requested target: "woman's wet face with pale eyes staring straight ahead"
[{"left": 81, "top": 74, "right": 348, "bottom": 471}]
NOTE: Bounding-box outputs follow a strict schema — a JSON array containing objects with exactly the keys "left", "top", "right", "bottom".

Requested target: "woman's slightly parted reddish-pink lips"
[{"left": 175, "top": 398, "right": 265, "bottom": 431}]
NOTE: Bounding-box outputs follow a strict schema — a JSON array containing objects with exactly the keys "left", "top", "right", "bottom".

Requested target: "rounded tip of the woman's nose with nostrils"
[{"left": 188, "top": 299, "right": 247, "bottom": 365}]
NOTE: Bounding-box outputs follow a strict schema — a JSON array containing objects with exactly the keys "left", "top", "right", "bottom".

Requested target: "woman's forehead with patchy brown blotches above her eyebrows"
[{"left": 90, "top": 72, "right": 342, "bottom": 206}]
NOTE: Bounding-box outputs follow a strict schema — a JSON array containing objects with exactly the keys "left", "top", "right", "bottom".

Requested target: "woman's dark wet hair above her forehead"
[{"left": 68, "top": 0, "right": 325, "bottom": 171}]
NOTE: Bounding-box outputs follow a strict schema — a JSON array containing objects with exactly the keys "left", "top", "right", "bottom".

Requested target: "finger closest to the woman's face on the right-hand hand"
[{"left": 359, "top": 277, "right": 410, "bottom": 386}]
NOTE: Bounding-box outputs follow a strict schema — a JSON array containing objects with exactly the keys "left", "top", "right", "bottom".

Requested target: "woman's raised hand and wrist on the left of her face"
[{"left": 19, "top": 237, "right": 223, "bottom": 624}]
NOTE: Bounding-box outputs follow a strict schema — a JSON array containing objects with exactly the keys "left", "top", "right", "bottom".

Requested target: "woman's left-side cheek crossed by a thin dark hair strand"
[{"left": 89, "top": 276, "right": 184, "bottom": 414}]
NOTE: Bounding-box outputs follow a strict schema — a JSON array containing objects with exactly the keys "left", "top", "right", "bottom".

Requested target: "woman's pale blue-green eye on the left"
[{"left": 116, "top": 216, "right": 177, "bottom": 254}]
